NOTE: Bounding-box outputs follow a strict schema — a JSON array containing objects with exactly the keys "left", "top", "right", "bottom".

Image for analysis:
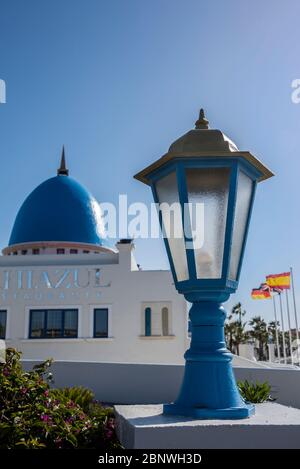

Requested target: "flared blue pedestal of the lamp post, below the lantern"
[{"left": 164, "top": 298, "right": 255, "bottom": 420}]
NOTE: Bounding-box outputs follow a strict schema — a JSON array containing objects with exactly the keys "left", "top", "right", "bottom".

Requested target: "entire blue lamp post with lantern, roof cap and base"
[{"left": 135, "top": 109, "right": 273, "bottom": 419}]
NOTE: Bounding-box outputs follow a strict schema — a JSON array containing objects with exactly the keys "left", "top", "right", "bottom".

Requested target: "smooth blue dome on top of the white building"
[{"left": 9, "top": 175, "right": 108, "bottom": 246}]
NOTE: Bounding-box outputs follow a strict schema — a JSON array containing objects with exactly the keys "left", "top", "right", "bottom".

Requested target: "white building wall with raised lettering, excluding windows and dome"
[{"left": 0, "top": 244, "right": 188, "bottom": 363}]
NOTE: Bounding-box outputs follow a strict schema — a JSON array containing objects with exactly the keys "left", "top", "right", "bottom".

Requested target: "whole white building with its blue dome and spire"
[{"left": 0, "top": 154, "right": 189, "bottom": 363}]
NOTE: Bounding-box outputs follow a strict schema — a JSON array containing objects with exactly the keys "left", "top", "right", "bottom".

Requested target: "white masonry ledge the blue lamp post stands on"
[{"left": 115, "top": 403, "right": 300, "bottom": 449}]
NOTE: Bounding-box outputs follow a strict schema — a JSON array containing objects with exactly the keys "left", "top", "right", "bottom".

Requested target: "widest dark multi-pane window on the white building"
[{"left": 29, "top": 309, "right": 78, "bottom": 339}]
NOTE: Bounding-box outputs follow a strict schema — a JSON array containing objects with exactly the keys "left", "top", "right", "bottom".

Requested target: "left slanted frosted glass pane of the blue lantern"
[{"left": 156, "top": 171, "right": 189, "bottom": 282}]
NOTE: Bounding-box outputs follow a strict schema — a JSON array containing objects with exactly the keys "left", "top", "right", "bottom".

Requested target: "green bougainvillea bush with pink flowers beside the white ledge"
[{"left": 0, "top": 348, "right": 119, "bottom": 450}]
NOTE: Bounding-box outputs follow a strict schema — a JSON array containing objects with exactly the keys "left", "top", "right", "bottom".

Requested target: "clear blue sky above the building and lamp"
[{"left": 0, "top": 0, "right": 300, "bottom": 326}]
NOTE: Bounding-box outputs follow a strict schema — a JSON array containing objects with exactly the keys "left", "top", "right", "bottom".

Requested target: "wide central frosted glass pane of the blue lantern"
[{"left": 186, "top": 168, "right": 230, "bottom": 279}]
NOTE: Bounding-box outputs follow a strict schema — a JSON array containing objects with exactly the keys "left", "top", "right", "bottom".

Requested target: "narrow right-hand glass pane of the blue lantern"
[{"left": 229, "top": 171, "right": 253, "bottom": 280}]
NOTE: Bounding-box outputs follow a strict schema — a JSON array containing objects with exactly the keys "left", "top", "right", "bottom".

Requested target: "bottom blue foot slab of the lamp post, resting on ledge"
[{"left": 163, "top": 403, "right": 255, "bottom": 420}]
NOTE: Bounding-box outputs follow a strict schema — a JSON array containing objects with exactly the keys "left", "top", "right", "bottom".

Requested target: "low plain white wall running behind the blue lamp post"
[{"left": 24, "top": 362, "right": 300, "bottom": 408}]
